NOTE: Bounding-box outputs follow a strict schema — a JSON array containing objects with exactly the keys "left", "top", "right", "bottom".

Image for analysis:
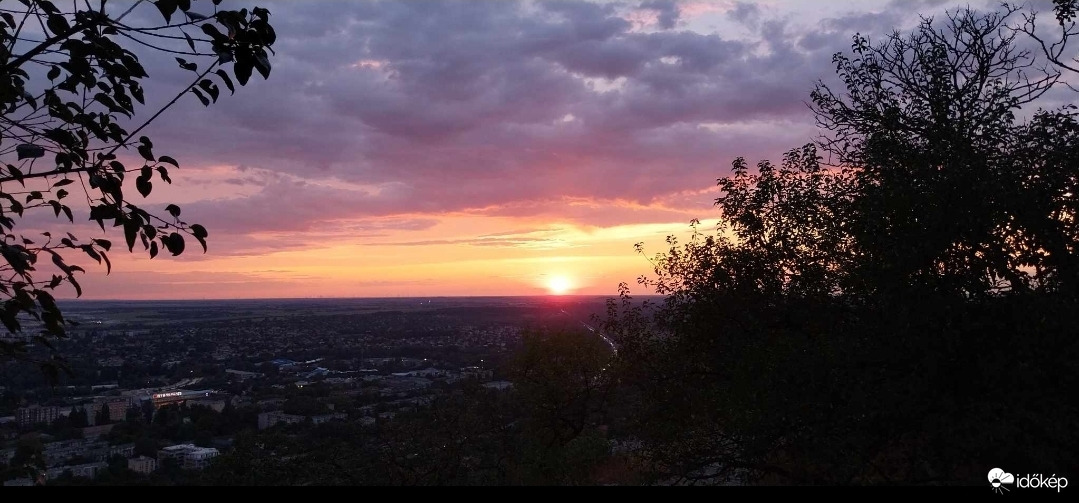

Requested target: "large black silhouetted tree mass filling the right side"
[{"left": 604, "top": 2, "right": 1079, "bottom": 484}]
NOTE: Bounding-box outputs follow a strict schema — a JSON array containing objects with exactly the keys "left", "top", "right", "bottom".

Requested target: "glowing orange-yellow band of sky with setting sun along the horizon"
[{"left": 58, "top": 215, "right": 707, "bottom": 300}]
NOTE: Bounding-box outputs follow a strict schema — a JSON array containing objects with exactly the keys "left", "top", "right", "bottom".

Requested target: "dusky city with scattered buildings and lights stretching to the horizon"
[{"left": 0, "top": 298, "right": 621, "bottom": 486}]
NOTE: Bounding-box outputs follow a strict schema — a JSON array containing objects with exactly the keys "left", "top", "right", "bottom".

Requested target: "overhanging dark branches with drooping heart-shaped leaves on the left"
[{"left": 0, "top": 0, "right": 276, "bottom": 377}]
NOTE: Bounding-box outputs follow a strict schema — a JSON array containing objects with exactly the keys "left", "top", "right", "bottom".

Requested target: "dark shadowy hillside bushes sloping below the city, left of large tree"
[{"left": 201, "top": 331, "right": 625, "bottom": 486}]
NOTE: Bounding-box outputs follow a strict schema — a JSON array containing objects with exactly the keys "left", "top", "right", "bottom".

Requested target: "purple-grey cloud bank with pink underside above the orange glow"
[{"left": 50, "top": 0, "right": 966, "bottom": 241}]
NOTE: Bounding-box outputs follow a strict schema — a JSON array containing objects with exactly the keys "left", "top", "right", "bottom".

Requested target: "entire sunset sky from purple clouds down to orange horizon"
[{"left": 14, "top": 0, "right": 1035, "bottom": 299}]
